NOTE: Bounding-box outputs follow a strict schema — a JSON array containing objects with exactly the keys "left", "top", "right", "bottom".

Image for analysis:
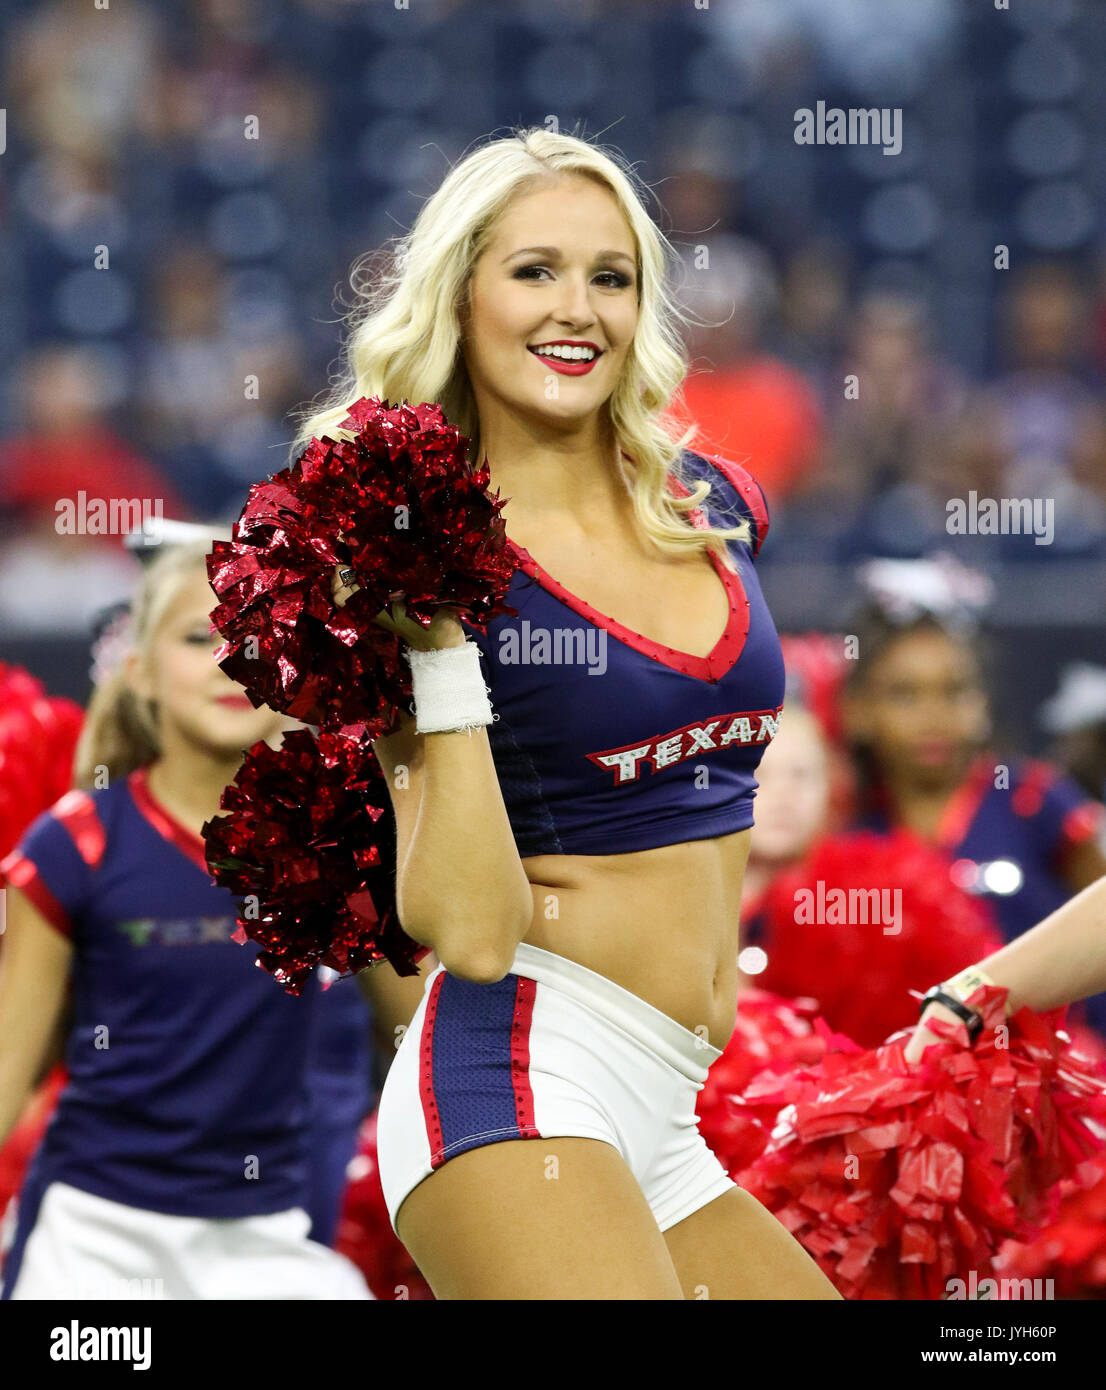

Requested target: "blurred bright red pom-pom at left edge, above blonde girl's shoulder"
[{"left": 0, "top": 662, "right": 85, "bottom": 859}]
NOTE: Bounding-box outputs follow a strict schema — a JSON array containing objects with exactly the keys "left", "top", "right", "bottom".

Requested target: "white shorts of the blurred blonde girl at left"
[{"left": 0, "top": 1183, "right": 372, "bottom": 1300}]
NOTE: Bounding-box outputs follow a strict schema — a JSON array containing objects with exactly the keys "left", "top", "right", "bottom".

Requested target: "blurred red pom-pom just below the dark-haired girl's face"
[{"left": 756, "top": 831, "right": 1003, "bottom": 1047}]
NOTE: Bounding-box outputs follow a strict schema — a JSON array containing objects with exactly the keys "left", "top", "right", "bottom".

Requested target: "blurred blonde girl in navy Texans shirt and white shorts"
[{"left": 0, "top": 541, "right": 414, "bottom": 1298}]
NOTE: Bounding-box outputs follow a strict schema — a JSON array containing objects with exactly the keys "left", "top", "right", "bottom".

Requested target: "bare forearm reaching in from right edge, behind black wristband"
[{"left": 977, "top": 878, "right": 1106, "bottom": 1013}]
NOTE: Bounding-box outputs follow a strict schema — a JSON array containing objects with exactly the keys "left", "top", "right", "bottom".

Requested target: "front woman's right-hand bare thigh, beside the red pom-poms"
[{"left": 663, "top": 1187, "right": 841, "bottom": 1300}]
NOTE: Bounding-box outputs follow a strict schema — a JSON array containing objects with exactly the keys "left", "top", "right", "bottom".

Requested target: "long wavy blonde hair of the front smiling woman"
[{"left": 292, "top": 128, "right": 750, "bottom": 569}]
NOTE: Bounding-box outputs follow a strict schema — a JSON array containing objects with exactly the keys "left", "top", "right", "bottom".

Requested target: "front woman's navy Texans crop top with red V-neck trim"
[{"left": 465, "top": 450, "right": 784, "bottom": 858}]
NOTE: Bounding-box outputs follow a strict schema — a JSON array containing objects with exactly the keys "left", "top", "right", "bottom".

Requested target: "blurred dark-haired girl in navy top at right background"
[{"left": 843, "top": 603, "right": 1106, "bottom": 1034}]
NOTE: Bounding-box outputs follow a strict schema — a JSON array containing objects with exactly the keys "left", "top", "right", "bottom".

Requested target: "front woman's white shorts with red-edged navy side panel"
[{"left": 377, "top": 941, "right": 736, "bottom": 1230}]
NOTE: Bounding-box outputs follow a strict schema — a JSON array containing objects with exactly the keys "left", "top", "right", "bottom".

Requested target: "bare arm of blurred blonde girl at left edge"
[{"left": 0, "top": 887, "right": 72, "bottom": 1144}]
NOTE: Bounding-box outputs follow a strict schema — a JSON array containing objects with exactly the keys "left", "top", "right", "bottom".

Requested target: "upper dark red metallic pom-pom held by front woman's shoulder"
[{"left": 207, "top": 396, "right": 517, "bottom": 737}]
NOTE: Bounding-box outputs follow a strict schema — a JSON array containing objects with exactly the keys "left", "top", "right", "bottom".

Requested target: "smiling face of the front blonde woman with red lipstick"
[{"left": 461, "top": 177, "right": 639, "bottom": 427}]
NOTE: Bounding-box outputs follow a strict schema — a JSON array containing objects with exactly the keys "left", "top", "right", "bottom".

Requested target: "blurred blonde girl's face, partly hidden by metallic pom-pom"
[{"left": 128, "top": 567, "right": 288, "bottom": 758}]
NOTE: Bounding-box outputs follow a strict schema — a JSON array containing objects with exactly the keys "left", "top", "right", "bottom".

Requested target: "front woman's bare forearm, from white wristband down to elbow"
[{"left": 396, "top": 728, "right": 534, "bottom": 979}]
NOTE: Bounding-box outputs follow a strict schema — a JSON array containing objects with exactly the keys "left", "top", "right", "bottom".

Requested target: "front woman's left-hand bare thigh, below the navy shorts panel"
[{"left": 396, "top": 1137, "right": 684, "bottom": 1300}]
